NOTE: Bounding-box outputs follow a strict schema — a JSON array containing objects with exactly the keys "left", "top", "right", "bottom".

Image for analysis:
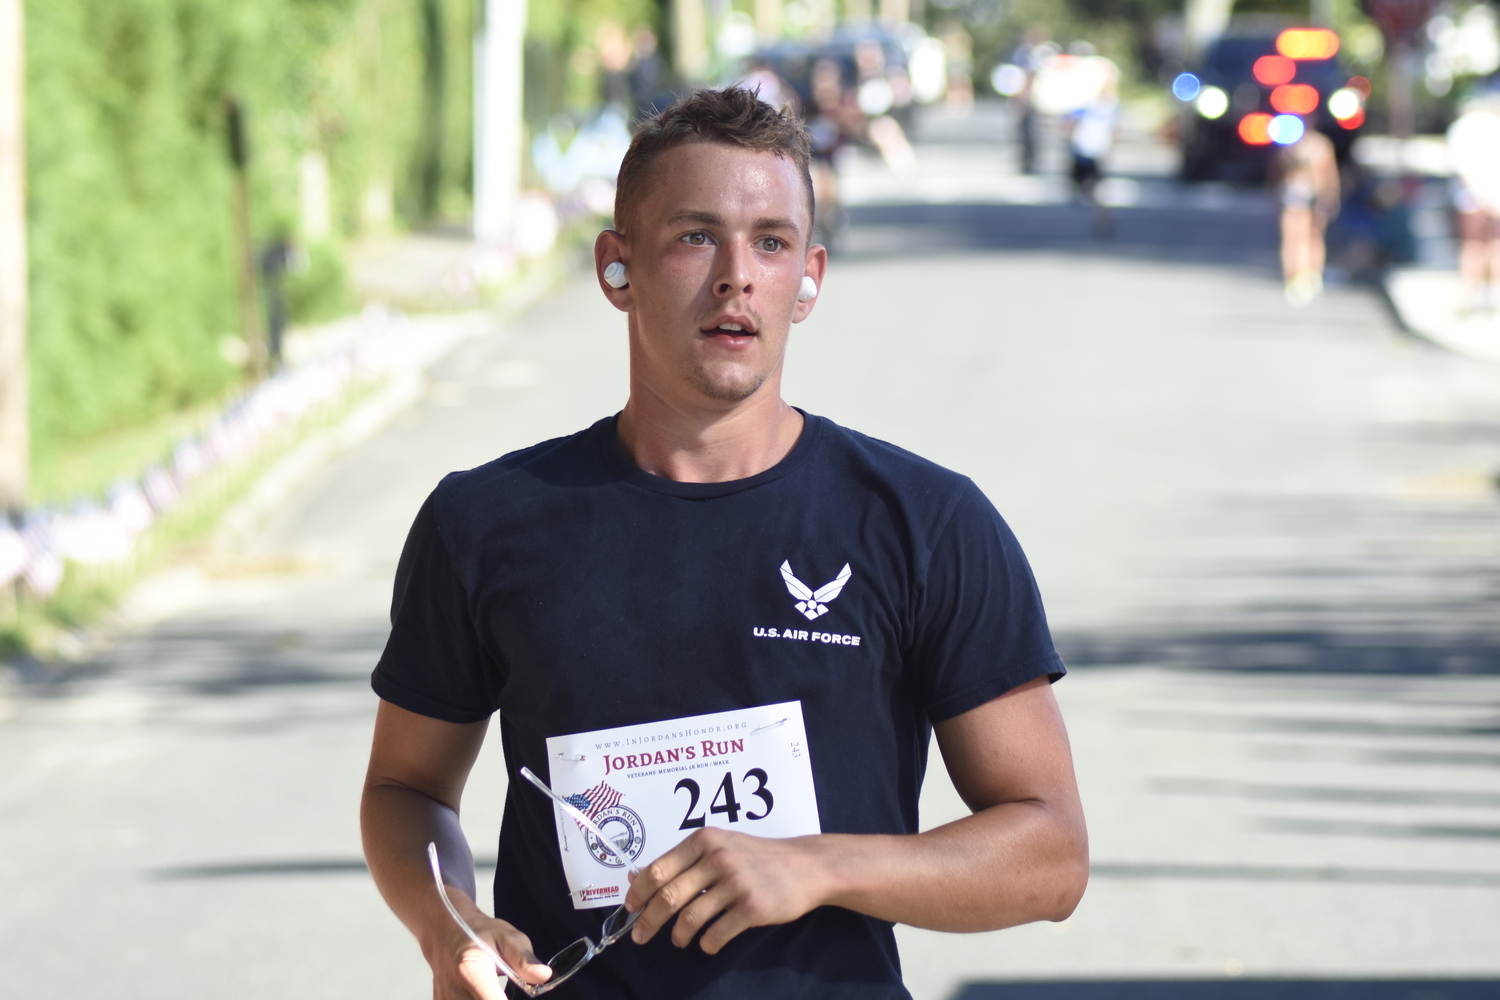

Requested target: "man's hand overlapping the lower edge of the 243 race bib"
[{"left": 626, "top": 828, "right": 830, "bottom": 955}]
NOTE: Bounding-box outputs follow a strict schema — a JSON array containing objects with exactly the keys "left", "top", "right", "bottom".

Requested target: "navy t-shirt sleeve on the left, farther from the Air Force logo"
[{"left": 371, "top": 496, "right": 501, "bottom": 723}]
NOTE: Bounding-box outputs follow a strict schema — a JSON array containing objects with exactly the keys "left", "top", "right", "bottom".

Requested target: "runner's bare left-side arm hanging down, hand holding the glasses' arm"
[{"left": 360, "top": 700, "right": 551, "bottom": 1000}]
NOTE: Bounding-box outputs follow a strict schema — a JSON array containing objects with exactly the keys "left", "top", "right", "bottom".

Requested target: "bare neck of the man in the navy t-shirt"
[{"left": 617, "top": 378, "right": 804, "bottom": 483}]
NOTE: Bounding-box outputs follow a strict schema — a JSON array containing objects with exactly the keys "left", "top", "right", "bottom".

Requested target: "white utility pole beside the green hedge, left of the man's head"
[{"left": 474, "top": 0, "right": 527, "bottom": 246}]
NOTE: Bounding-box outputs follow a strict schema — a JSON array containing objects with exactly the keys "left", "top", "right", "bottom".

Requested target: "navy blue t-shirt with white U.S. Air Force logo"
[{"left": 372, "top": 415, "right": 1064, "bottom": 1000}]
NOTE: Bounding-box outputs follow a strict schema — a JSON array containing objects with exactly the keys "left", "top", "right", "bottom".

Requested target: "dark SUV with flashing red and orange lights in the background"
[{"left": 1173, "top": 27, "right": 1368, "bottom": 183}]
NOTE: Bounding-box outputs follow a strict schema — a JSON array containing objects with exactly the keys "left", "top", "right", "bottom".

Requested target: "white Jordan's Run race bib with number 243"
[{"left": 548, "top": 702, "right": 822, "bottom": 910}]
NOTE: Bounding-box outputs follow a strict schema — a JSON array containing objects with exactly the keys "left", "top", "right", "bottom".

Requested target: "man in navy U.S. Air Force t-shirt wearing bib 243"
[{"left": 362, "top": 88, "right": 1088, "bottom": 1000}]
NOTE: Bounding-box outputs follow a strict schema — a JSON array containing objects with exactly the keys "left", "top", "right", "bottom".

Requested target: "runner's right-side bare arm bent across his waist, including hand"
[{"left": 626, "top": 678, "right": 1089, "bottom": 954}]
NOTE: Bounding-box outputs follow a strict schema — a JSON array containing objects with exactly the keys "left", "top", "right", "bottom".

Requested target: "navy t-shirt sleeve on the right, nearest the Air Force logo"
[{"left": 912, "top": 483, "right": 1067, "bottom": 723}]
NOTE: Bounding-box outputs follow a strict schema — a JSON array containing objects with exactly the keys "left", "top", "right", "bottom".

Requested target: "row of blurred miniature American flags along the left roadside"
[{"left": 0, "top": 307, "right": 404, "bottom": 597}]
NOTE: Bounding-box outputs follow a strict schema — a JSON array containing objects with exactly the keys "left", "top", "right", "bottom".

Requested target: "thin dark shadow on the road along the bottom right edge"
[{"left": 954, "top": 979, "right": 1500, "bottom": 1000}]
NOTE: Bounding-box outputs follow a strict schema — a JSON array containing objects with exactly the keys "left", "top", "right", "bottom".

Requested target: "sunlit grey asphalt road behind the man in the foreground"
[{"left": 0, "top": 122, "right": 1500, "bottom": 1000}]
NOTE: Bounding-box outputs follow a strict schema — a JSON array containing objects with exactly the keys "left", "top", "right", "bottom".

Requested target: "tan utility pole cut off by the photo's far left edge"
[{"left": 0, "top": 0, "right": 32, "bottom": 513}]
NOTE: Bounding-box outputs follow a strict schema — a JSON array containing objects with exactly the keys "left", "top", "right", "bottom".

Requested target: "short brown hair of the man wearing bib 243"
[{"left": 615, "top": 87, "right": 815, "bottom": 235}]
